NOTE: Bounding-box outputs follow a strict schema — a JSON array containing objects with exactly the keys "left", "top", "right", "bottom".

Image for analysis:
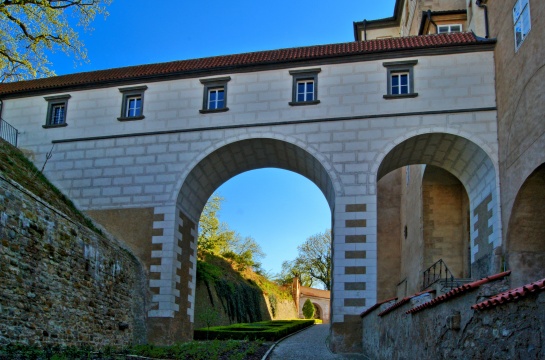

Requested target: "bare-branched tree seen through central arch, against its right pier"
[{"left": 278, "top": 230, "right": 331, "bottom": 290}]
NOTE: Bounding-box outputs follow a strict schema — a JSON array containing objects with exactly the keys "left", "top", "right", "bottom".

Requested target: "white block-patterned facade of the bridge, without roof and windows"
[{"left": 2, "top": 51, "right": 501, "bottom": 346}]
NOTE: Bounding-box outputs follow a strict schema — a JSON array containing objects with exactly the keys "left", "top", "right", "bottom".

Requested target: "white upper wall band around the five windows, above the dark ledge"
[{"left": 2, "top": 51, "right": 495, "bottom": 147}]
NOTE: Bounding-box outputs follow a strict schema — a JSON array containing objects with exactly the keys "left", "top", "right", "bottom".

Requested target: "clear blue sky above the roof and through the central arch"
[{"left": 50, "top": 0, "right": 395, "bottom": 273}]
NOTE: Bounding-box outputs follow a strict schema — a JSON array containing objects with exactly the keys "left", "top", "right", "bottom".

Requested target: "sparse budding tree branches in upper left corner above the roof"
[{"left": 0, "top": 0, "right": 112, "bottom": 82}]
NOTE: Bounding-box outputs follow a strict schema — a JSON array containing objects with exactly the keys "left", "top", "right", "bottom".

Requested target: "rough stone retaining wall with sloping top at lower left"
[{"left": 0, "top": 177, "right": 147, "bottom": 346}]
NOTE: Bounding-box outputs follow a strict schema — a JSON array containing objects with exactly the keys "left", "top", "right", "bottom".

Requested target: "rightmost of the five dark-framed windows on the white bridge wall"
[{"left": 382, "top": 60, "right": 418, "bottom": 99}]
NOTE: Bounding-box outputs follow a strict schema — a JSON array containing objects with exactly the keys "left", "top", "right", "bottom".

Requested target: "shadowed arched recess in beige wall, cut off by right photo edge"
[{"left": 506, "top": 163, "right": 545, "bottom": 287}]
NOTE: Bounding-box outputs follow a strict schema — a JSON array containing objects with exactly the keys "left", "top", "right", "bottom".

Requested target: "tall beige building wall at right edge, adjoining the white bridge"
[{"left": 488, "top": 0, "right": 545, "bottom": 237}]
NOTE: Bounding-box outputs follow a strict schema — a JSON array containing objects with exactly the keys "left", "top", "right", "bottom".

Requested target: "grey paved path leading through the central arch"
[{"left": 267, "top": 324, "right": 367, "bottom": 360}]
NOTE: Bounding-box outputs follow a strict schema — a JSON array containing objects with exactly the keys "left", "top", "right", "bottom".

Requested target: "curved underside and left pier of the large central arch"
[{"left": 149, "top": 138, "right": 335, "bottom": 339}]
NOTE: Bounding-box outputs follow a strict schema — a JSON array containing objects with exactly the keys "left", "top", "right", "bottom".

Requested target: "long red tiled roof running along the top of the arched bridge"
[{"left": 0, "top": 33, "right": 495, "bottom": 96}]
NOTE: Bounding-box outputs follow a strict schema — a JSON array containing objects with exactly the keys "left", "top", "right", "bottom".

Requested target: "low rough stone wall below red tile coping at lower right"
[{"left": 362, "top": 279, "right": 545, "bottom": 359}]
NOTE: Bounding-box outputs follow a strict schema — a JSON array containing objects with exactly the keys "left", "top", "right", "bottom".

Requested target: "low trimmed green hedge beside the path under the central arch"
[{"left": 193, "top": 320, "right": 314, "bottom": 341}]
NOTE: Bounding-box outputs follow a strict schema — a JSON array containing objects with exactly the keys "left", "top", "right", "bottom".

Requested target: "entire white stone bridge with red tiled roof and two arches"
[{"left": 0, "top": 34, "right": 502, "bottom": 352}]
